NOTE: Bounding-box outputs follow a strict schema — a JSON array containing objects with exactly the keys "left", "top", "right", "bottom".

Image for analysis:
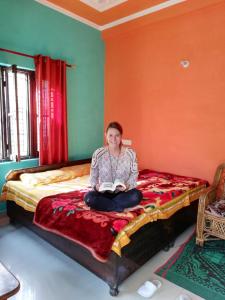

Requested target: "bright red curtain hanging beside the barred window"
[{"left": 35, "top": 55, "right": 68, "bottom": 165}]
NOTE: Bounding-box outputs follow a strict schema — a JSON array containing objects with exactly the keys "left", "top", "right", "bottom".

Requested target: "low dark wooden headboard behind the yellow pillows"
[{"left": 5, "top": 158, "right": 91, "bottom": 181}]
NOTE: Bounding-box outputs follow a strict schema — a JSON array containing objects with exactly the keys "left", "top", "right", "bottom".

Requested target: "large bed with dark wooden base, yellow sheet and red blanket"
[{"left": 1, "top": 159, "right": 208, "bottom": 296}]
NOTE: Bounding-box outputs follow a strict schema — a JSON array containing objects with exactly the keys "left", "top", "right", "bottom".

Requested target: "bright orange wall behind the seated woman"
[{"left": 105, "top": 1, "right": 225, "bottom": 182}]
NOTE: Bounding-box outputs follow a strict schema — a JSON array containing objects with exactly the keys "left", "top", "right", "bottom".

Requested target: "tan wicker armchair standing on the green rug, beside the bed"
[{"left": 196, "top": 163, "right": 225, "bottom": 246}]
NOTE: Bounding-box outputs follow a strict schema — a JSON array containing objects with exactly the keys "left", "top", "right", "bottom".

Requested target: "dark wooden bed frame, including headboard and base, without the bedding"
[{"left": 6, "top": 159, "right": 198, "bottom": 296}]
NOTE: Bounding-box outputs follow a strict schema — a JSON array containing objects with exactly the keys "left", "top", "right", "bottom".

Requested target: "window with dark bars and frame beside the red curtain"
[{"left": 0, "top": 66, "right": 38, "bottom": 161}]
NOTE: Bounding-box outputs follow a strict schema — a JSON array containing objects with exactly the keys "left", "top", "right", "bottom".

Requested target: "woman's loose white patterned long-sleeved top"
[{"left": 90, "top": 147, "right": 138, "bottom": 190}]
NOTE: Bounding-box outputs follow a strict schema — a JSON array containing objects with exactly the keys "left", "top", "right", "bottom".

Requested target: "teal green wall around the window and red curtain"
[{"left": 0, "top": 0, "right": 104, "bottom": 210}]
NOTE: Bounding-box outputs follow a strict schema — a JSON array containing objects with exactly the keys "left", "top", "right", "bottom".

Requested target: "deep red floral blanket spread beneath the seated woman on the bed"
[{"left": 34, "top": 170, "right": 207, "bottom": 261}]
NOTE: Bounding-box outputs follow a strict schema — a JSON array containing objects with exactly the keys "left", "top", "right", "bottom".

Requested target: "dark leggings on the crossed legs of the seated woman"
[{"left": 84, "top": 189, "right": 142, "bottom": 212}]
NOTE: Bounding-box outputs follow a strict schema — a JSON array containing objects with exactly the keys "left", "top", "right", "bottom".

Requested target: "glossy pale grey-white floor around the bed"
[{"left": 0, "top": 225, "right": 202, "bottom": 300}]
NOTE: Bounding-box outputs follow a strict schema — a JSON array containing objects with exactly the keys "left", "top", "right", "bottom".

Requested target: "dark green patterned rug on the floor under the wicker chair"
[{"left": 155, "top": 235, "right": 225, "bottom": 300}]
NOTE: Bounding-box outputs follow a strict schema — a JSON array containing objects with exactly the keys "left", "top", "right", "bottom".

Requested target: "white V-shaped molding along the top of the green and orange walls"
[{"left": 35, "top": 0, "right": 187, "bottom": 31}]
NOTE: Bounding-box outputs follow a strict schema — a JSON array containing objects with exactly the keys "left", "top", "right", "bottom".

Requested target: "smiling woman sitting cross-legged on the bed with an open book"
[{"left": 84, "top": 122, "right": 142, "bottom": 212}]
